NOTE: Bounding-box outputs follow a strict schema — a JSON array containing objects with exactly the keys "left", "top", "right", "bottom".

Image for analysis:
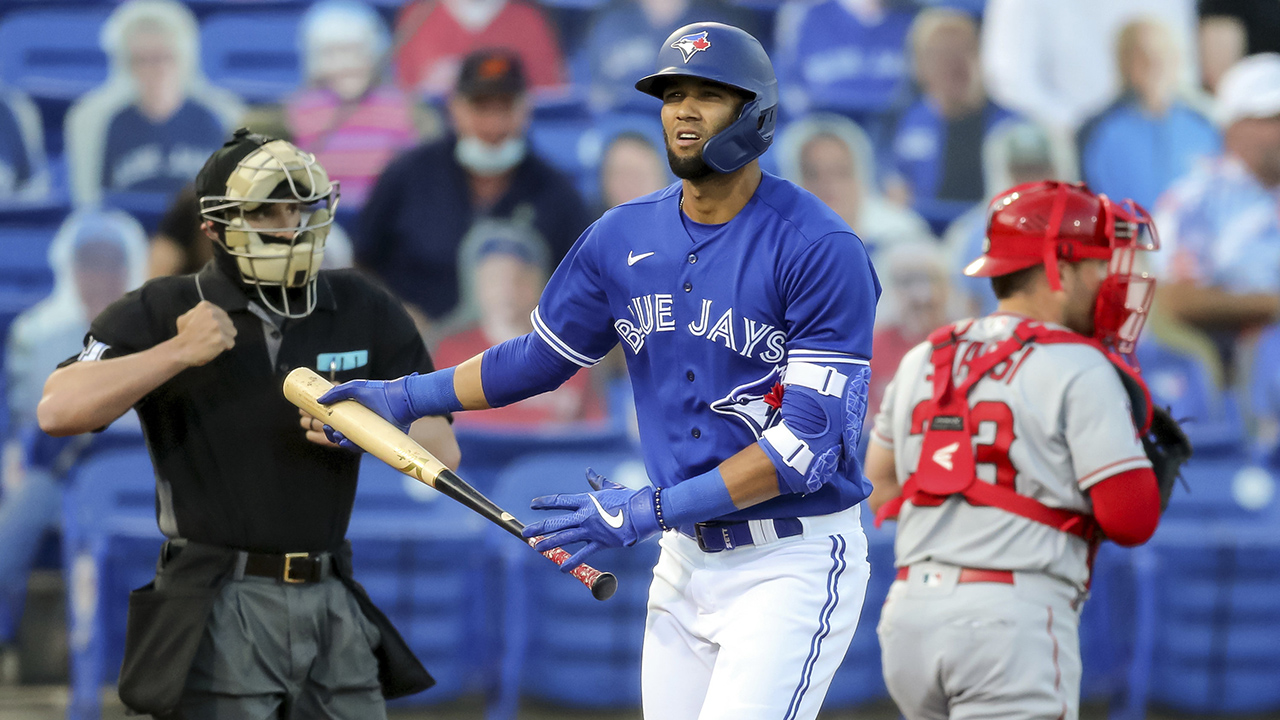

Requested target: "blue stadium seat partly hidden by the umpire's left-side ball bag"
[{"left": 63, "top": 443, "right": 164, "bottom": 719}]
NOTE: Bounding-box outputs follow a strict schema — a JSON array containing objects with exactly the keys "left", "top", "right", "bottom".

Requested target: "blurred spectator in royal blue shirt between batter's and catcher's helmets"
[{"left": 884, "top": 8, "right": 1012, "bottom": 233}]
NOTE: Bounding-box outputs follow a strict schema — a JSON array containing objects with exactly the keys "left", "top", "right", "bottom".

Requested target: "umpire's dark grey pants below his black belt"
[{"left": 158, "top": 568, "right": 387, "bottom": 720}]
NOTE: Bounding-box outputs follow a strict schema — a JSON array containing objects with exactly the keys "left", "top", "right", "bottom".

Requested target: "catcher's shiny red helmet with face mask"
[{"left": 964, "top": 181, "right": 1160, "bottom": 355}]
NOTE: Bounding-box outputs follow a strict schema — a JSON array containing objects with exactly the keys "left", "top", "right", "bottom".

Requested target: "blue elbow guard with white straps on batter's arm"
[{"left": 760, "top": 361, "right": 870, "bottom": 495}]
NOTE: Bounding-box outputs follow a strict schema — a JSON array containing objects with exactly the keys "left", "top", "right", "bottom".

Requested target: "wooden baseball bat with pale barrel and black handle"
[{"left": 284, "top": 368, "right": 618, "bottom": 600}]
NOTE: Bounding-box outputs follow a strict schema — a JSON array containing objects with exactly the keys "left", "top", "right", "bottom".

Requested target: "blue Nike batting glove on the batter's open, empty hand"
[{"left": 522, "top": 468, "right": 662, "bottom": 573}]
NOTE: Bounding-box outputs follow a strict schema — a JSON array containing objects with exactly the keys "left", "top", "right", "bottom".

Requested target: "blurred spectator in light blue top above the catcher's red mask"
[{"left": 1076, "top": 19, "right": 1221, "bottom": 208}]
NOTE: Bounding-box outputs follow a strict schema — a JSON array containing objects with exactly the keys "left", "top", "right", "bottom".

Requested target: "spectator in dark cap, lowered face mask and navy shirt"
[{"left": 356, "top": 49, "right": 591, "bottom": 333}]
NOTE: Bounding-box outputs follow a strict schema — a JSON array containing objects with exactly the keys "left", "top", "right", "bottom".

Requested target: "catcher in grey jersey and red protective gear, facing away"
[{"left": 867, "top": 182, "right": 1189, "bottom": 720}]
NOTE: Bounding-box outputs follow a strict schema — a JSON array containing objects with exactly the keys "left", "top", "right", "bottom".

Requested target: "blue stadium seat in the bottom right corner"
[{"left": 1151, "top": 515, "right": 1280, "bottom": 715}]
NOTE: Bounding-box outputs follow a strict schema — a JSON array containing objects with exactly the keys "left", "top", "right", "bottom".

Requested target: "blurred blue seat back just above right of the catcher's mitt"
[{"left": 1137, "top": 338, "right": 1244, "bottom": 452}]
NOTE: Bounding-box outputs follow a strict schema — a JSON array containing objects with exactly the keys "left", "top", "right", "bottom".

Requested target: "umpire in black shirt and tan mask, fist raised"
[{"left": 38, "top": 129, "right": 458, "bottom": 719}]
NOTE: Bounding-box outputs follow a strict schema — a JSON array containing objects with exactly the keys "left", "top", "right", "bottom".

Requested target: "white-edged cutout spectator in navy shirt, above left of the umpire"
[{"left": 65, "top": 0, "right": 243, "bottom": 209}]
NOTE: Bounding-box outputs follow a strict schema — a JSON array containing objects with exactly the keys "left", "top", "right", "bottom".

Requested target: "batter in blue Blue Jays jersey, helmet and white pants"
[{"left": 320, "top": 23, "right": 879, "bottom": 720}]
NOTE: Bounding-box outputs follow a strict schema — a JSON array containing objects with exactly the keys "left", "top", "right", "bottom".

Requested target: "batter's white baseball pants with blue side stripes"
[{"left": 641, "top": 506, "right": 870, "bottom": 720}]
